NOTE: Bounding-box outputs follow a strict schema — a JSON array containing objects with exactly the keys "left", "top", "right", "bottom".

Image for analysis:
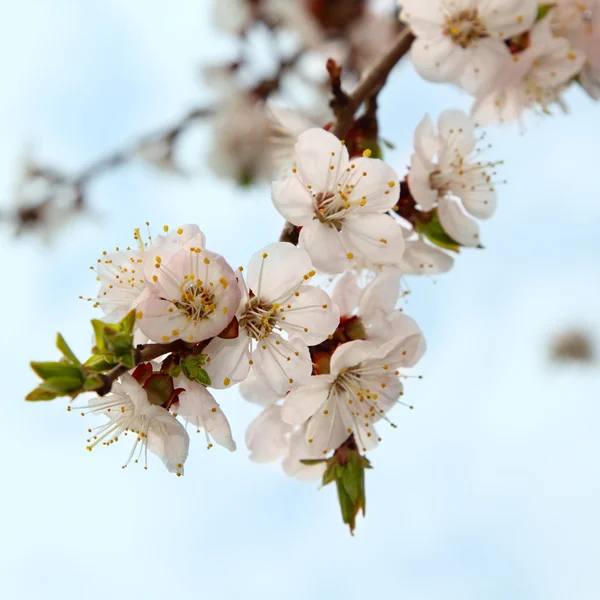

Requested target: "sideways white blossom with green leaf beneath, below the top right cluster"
[{"left": 408, "top": 110, "right": 498, "bottom": 246}]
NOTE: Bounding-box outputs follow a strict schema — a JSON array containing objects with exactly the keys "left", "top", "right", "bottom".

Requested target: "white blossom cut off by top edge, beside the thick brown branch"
[{"left": 400, "top": 0, "right": 538, "bottom": 93}]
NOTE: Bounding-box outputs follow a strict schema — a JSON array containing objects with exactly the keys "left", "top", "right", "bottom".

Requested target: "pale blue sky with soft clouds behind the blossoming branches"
[{"left": 0, "top": 0, "right": 600, "bottom": 600}]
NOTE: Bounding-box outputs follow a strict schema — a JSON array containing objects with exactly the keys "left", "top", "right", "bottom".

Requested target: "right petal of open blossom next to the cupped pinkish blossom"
[{"left": 277, "top": 285, "right": 340, "bottom": 346}]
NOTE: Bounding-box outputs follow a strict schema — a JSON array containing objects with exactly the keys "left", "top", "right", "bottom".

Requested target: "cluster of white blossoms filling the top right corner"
[{"left": 400, "top": 0, "right": 600, "bottom": 123}]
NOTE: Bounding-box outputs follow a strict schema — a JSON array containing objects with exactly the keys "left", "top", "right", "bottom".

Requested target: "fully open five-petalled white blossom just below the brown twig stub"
[{"left": 272, "top": 129, "right": 404, "bottom": 274}]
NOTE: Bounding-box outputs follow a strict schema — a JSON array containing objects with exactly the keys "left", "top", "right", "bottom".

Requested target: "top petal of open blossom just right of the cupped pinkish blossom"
[{"left": 246, "top": 242, "right": 312, "bottom": 302}]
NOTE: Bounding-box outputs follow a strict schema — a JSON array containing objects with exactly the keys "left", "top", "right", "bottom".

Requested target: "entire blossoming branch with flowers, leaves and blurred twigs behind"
[{"left": 21, "top": 0, "right": 600, "bottom": 531}]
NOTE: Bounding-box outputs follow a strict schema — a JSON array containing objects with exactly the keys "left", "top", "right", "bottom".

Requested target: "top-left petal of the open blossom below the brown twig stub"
[{"left": 296, "top": 128, "right": 348, "bottom": 192}]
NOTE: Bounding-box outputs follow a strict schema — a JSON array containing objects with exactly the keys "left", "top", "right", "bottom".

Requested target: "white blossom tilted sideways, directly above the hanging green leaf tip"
[{"left": 281, "top": 329, "right": 425, "bottom": 457}]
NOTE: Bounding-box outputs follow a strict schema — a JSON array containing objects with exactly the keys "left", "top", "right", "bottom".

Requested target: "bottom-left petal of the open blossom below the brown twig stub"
[{"left": 299, "top": 221, "right": 352, "bottom": 275}]
